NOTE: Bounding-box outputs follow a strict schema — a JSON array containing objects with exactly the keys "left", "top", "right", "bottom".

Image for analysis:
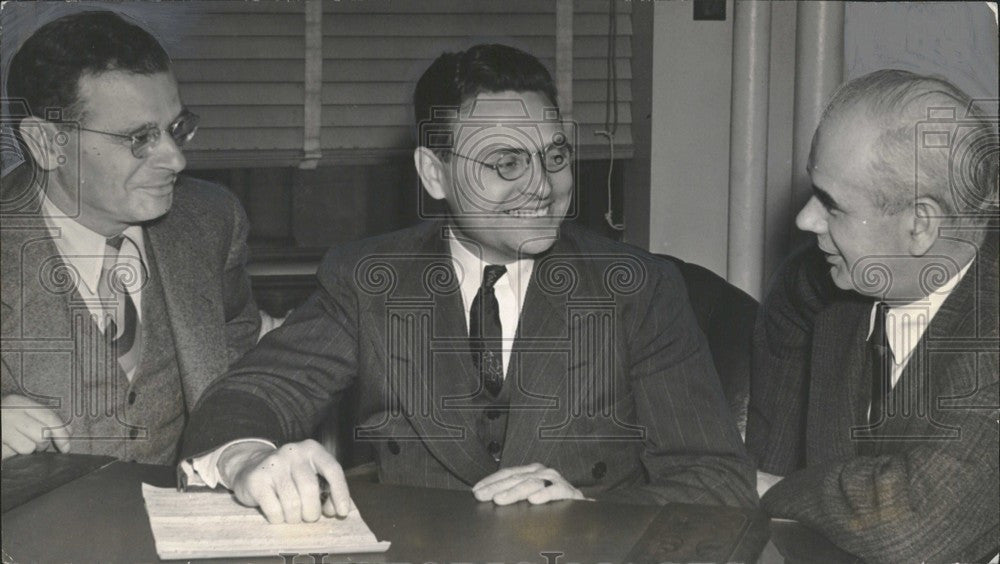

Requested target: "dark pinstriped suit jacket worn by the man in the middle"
[{"left": 183, "top": 219, "right": 756, "bottom": 505}]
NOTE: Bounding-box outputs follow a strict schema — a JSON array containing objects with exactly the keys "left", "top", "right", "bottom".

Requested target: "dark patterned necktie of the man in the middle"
[{"left": 469, "top": 264, "right": 507, "bottom": 397}]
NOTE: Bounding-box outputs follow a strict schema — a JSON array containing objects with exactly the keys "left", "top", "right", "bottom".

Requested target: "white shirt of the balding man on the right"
[{"left": 868, "top": 261, "right": 972, "bottom": 388}]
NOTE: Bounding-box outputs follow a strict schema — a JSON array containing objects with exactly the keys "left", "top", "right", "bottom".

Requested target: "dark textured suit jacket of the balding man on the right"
[{"left": 747, "top": 230, "right": 1000, "bottom": 562}]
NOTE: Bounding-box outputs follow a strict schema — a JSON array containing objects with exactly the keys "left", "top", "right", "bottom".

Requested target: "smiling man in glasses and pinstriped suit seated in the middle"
[{"left": 182, "top": 45, "right": 756, "bottom": 522}]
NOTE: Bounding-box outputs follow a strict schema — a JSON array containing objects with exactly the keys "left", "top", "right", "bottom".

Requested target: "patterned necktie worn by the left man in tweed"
[{"left": 98, "top": 235, "right": 143, "bottom": 374}]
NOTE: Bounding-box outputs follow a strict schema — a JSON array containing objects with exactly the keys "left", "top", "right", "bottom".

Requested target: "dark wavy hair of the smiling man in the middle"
[{"left": 413, "top": 43, "right": 558, "bottom": 148}]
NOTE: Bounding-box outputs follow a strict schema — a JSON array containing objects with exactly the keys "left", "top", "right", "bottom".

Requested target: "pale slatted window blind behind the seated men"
[{"left": 169, "top": 0, "right": 632, "bottom": 168}]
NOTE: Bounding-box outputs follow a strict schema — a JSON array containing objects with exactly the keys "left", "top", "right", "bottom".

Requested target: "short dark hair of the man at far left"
[{"left": 7, "top": 11, "right": 170, "bottom": 123}]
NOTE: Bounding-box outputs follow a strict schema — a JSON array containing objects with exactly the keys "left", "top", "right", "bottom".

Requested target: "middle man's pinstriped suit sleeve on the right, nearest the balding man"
[{"left": 600, "top": 265, "right": 757, "bottom": 507}]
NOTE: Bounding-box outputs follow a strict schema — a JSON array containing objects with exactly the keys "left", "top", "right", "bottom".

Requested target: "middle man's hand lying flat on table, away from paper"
[{"left": 472, "top": 462, "right": 586, "bottom": 505}]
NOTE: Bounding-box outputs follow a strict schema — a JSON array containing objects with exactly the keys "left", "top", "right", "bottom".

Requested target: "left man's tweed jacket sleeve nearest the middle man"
[{"left": 222, "top": 196, "right": 260, "bottom": 366}]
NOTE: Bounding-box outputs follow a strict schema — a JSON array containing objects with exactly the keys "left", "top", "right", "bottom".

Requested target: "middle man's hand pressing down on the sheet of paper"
[{"left": 218, "top": 440, "right": 352, "bottom": 523}]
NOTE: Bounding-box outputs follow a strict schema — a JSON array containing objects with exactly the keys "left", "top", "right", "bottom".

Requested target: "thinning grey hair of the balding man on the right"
[{"left": 820, "top": 69, "right": 998, "bottom": 223}]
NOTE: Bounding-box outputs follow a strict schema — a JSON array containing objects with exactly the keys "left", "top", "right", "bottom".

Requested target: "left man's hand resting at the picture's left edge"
[{"left": 0, "top": 394, "right": 70, "bottom": 459}]
